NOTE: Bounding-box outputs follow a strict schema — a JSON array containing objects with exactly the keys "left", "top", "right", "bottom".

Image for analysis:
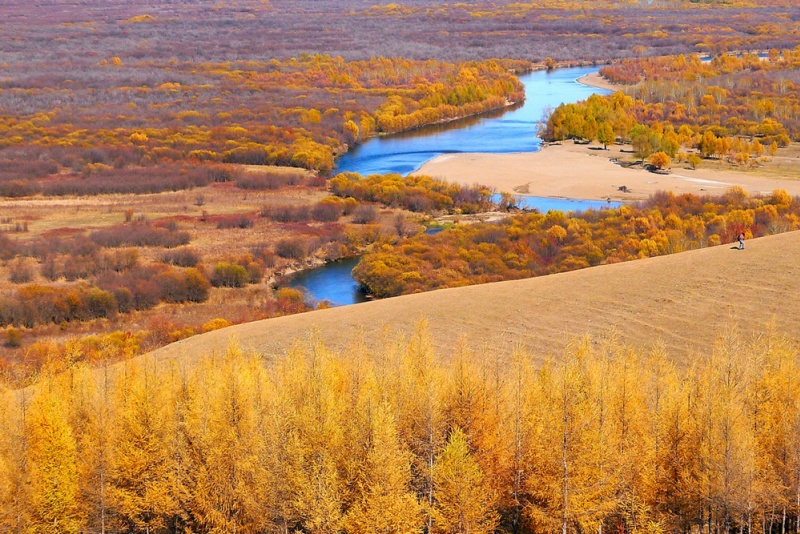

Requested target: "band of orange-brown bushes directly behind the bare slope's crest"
[{"left": 353, "top": 188, "right": 800, "bottom": 297}]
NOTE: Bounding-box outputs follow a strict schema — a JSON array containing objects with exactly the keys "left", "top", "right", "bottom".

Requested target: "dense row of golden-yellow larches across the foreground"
[{"left": 0, "top": 325, "right": 800, "bottom": 534}]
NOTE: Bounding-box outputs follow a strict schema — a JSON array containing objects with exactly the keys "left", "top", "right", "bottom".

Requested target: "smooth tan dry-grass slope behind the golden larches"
[{"left": 148, "top": 232, "right": 800, "bottom": 363}]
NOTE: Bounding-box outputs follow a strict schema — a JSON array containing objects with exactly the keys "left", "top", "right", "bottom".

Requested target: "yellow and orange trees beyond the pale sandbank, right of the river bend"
[{"left": 541, "top": 49, "right": 800, "bottom": 169}]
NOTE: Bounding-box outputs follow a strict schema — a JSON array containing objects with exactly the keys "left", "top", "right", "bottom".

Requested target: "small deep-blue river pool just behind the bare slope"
[{"left": 289, "top": 258, "right": 367, "bottom": 306}]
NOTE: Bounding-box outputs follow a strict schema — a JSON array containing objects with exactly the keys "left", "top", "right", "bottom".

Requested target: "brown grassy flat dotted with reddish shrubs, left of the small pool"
[{"left": 0, "top": 172, "right": 416, "bottom": 376}]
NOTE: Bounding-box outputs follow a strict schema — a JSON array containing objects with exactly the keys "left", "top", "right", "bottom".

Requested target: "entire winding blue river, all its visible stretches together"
[{"left": 289, "top": 67, "right": 606, "bottom": 306}]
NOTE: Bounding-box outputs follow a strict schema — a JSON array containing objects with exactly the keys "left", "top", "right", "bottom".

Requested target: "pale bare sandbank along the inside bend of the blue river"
[{"left": 415, "top": 141, "right": 800, "bottom": 201}]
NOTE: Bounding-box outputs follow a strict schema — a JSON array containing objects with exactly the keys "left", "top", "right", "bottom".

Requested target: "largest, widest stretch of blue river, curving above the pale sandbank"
[{"left": 336, "top": 67, "right": 608, "bottom": 176}]
